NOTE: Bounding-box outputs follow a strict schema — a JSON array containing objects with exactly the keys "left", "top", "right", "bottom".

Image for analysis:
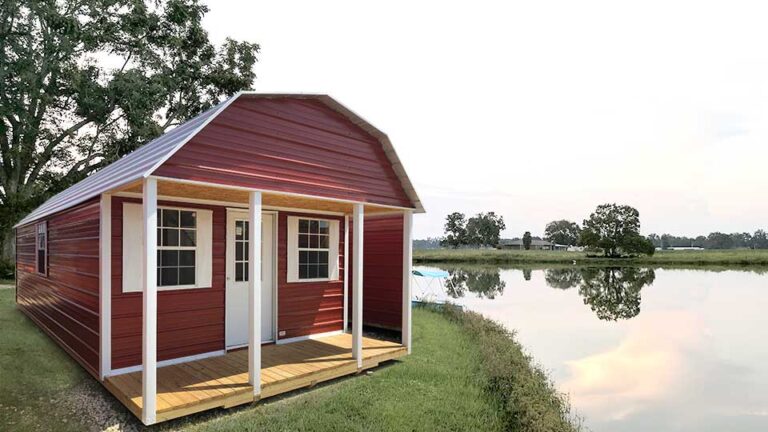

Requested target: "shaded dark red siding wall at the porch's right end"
[{"left": 348, "top": 214, "right": 403, "bottom": 330}]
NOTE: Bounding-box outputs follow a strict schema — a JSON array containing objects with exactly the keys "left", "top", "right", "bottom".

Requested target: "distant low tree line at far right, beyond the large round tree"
[{"left": 648, "top": 229, "right": 768, "bottom": 249}]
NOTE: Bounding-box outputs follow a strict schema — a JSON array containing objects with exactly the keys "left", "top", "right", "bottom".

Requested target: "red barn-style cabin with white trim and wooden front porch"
[{"left": 16, "top": 92, "right": 423, "bottom": 424}]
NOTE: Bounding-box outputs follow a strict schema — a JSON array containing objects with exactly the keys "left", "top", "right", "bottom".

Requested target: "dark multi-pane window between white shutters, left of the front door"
[{"left": 157, "top": 208, "right": 197, "bottom": 287}]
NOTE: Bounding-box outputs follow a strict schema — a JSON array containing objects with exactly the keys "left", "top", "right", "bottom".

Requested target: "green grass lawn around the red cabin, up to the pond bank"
[{"left": 0, "top": 289, "right": 504, "bottom": 431}]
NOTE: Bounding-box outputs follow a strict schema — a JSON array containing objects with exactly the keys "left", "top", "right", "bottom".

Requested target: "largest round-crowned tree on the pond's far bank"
[{"left": 579, "top": 204, "right": 655, "bottom": 257}]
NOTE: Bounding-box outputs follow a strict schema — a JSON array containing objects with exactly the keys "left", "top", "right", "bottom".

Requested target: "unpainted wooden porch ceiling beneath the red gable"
[{"left": 120, "top": 180, "right": 404, "bottom": 214}]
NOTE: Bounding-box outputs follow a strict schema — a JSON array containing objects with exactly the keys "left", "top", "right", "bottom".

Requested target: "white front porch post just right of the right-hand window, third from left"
[{"left": 352, "top": 204, "right": 364, "bottom": 369}]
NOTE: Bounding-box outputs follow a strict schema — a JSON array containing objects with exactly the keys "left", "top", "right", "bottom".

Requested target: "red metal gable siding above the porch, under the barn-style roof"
[{"left": 155, "top": 97, "right": 412, "bottom": 207}]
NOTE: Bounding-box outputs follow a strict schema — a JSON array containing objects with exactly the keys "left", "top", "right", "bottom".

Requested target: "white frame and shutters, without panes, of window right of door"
[{"left": 287, "top": 216, "right": 340, "bottom": 283}]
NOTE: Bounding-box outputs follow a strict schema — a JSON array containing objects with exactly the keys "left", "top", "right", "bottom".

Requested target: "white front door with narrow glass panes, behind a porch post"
[{"left": 225, "top": 211, "right": 275, "bottom": 348}]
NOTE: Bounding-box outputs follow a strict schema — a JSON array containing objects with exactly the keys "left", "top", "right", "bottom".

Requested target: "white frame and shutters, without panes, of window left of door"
[{"left": 122, "top": 202, "right": 213, "bottom": 293}]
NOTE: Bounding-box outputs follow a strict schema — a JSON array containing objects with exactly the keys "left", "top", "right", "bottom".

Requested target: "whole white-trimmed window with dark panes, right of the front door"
[{"left": 288, "top": 216, "right": 339, "bottom": 282}]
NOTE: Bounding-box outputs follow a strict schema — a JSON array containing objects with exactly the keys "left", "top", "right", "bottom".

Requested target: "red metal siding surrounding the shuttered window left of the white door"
[{"left": 112, "top": 197, "right": 227, "bottom": 369}]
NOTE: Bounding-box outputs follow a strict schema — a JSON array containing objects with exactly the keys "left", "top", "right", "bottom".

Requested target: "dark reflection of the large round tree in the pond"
[{"left": 579, "top": 267, "right": 656, "bottom": 321}]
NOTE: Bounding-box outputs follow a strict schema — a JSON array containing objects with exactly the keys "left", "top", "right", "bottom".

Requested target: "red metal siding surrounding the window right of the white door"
[{"left": 277, "top": 212, "right": 344, "bottom": 339}]
